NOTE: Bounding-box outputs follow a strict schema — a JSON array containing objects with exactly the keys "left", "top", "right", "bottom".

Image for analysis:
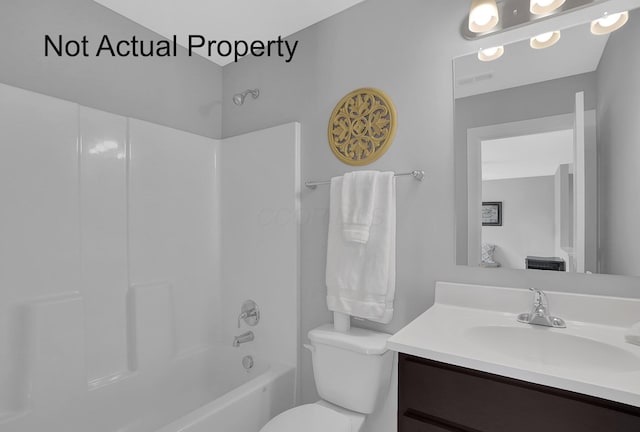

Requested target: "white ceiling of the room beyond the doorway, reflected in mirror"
[{"left": 482, "top": 130, "right": 573, "bottom": 180}]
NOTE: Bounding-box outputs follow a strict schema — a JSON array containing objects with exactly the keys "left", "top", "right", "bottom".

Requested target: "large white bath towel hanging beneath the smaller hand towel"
[{"left": 326, "top": 172, "right": 396, "bottom": 324}]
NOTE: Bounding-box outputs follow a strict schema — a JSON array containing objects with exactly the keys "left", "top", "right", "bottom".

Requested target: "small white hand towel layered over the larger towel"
[{"left": 342, "top": 171, "right": 379, "bottom": 243}]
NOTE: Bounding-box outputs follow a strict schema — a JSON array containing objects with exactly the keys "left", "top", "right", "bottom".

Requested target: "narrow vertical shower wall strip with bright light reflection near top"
[{"left": 79, "top": 106, "right": 128, "bottom": 383}]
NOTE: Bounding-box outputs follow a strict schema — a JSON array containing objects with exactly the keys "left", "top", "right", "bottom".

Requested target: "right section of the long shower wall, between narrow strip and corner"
[{"left": 129, "top": 120, "right": 222, "bottom": 353}]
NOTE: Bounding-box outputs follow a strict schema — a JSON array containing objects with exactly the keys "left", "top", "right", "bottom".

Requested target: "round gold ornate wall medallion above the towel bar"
[{"left": 329, "top": 88, "right": 397, "bottom": 165}]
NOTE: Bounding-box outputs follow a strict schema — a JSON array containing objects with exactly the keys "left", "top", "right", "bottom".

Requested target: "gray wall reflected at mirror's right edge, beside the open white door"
[{"left": 597, "top": 10, "right": 640, "bottom": 275}]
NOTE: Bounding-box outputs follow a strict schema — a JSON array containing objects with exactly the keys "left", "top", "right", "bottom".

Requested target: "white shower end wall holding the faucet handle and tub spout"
[{"left": 220, "top": 123, "right": 301, "bottom": 374}]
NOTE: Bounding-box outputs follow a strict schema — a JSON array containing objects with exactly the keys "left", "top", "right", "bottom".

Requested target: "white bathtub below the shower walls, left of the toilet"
[{"left": 0, "top": 347, "right": 295, "bottom": 432}]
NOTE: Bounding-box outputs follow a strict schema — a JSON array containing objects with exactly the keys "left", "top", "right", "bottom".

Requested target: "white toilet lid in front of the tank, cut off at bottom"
[{"left": 260, "top": 404, "right": 351, "bottom": 432}]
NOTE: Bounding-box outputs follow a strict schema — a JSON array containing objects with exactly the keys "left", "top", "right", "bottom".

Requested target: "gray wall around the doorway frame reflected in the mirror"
[{"left": 454, "top": 72, "right": 596, "bottom": 263}]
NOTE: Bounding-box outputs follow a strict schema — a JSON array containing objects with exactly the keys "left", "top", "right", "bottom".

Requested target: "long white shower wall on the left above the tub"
[{"left": 0, "top": 84, "right": 222, "bottom": 420}]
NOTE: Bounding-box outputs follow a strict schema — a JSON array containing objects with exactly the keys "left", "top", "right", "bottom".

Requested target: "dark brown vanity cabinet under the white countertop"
[{"left": 398, "top": 354, "right": 640, "bottom": 432}]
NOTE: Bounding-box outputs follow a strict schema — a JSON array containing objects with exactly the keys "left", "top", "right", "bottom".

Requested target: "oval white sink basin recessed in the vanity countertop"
[{"left": 465, "top": 326, "right": 640, "bottom": 372}]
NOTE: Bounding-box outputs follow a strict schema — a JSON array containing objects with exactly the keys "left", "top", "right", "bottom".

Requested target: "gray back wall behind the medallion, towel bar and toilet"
[{"left": 223, "top": 0, "right": 640, "bottom": 412}]
